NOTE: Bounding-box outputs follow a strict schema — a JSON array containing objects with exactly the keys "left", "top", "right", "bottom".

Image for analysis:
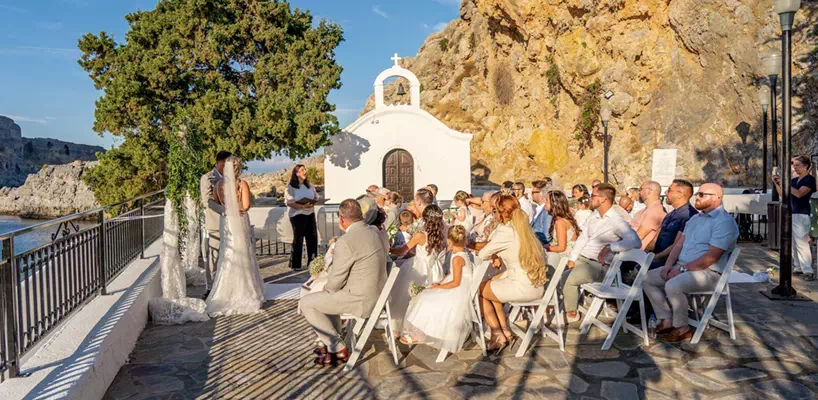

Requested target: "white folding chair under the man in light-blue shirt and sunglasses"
[{"left": 688, "top": 248, "right": 741, "bottom": 344}]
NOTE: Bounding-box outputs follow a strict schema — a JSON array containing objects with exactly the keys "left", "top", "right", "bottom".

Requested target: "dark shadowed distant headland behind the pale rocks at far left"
[{"left": 0, "top": 115, "right": 105, "bottom": 186}]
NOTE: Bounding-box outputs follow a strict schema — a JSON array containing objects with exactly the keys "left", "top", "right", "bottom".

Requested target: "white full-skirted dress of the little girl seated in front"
[{"left": 402, "top": 252, "right": 473, "bottom": 353}]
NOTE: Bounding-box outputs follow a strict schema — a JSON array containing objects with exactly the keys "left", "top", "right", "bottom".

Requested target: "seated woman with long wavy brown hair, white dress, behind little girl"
[{"left": 389, "top": 204, "right": 446, "bottom": 332}]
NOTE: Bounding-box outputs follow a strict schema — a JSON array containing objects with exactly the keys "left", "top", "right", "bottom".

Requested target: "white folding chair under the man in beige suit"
[{"left": 341, "top": 263, "right": 400, "bottom": 373}]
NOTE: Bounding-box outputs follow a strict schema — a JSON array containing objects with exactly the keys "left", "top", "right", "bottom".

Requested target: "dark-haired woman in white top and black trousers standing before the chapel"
[{"left": 284, "top": 164, "right": 318, "bottom": 270}]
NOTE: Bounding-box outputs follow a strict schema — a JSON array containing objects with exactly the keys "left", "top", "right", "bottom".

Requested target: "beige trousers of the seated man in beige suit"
[{"left": 299, "top": 292, "right": 349, "bottom": 353}]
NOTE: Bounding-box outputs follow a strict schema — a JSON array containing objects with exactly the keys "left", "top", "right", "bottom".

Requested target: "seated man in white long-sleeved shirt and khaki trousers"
[{"left": 563, "top": 183, "right": 642, "bottom": 323}]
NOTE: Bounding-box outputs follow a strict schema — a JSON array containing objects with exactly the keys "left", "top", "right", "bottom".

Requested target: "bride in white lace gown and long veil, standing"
[{"left": 206, "top": 156, "right": 264, "bottom": 316}]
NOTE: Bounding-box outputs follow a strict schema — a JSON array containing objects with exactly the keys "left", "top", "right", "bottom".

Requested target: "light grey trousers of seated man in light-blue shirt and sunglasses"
[{"left": 642, "top": 268, "right": 721, "bottom": 328}]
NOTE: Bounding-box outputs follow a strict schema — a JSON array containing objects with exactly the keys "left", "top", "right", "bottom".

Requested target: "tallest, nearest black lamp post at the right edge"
[{"left": 772, "top": 0, "right": 801, "bottom": 298}]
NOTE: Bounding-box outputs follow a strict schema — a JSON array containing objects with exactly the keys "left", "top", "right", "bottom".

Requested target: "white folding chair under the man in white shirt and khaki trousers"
[{"left": 580, "top": 249, "right": 653, "bottom": 350}]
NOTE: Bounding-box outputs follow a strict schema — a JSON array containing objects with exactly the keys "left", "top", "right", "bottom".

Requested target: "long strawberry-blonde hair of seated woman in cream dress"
[{"left": 497, "top": 194, "right": 548, "bottom": 286}]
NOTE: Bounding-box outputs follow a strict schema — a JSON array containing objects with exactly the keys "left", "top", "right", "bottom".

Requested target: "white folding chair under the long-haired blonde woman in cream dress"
[{"left": 508, "top": 257, "right": 568, "bottom": 357}]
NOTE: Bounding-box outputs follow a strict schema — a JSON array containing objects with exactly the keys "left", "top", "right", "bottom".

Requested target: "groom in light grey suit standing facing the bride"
[{"left": 199, "top": 151, "right": 232, "bottom": 297}]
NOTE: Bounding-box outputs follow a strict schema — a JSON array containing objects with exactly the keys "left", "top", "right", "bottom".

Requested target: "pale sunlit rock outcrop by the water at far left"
[{"left": 0, "top": 161, "right": 99, "bottom": 218}]
